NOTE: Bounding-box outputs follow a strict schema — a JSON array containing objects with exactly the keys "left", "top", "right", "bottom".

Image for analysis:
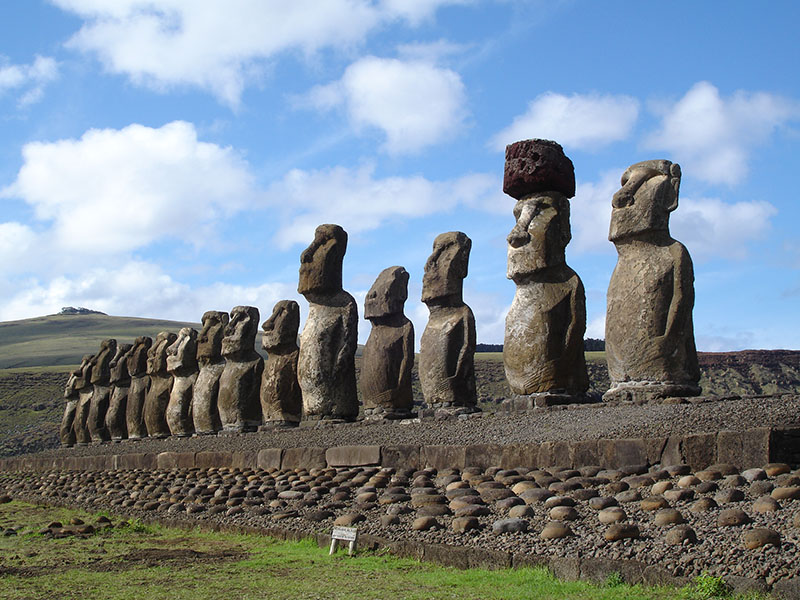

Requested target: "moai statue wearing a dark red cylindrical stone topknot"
[{"left": 503, "top": 139, "right": 592, "bottom": 408}]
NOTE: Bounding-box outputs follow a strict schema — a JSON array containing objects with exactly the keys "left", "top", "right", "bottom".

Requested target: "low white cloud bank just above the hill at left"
[{"left": 0, "top": 260, "right": 298, "bottom": 321}]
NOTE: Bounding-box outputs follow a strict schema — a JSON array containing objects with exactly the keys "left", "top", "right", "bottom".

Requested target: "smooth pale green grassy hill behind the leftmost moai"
[{"left": 0, "top": 314, "right": 200, "bottom": 369}]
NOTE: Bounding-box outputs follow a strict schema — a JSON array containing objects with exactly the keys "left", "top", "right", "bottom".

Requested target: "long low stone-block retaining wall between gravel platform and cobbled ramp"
[{"left": 0, "top": 427, "right": 800, "bottom": 471}]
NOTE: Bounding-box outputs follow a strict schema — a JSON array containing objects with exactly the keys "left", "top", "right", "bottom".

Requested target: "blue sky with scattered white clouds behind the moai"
[{"left": 0, "top": 0, "right": 800, "bottom": 351}]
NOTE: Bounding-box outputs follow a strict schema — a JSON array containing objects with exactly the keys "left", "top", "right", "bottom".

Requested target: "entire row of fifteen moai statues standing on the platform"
[{"left": 62, "top": 140, "right": 700, "bottom": 445}]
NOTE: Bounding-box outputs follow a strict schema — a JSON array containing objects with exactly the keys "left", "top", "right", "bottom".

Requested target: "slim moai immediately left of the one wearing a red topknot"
[{"left": 419, "top": 231, "right": 478, "bottom": 413}]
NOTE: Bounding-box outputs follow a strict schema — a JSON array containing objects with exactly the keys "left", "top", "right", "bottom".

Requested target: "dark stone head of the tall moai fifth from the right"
[{"left": 297, "top": 225, "right": 347, "bottom": 295}]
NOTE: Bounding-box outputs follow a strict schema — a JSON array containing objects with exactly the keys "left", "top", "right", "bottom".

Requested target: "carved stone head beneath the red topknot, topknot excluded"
[{"left": 507, "top": 192, "right": 571, "bottom": 281}]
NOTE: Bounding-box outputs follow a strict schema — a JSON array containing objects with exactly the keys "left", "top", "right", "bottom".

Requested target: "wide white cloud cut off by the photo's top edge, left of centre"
[{"left": 54, "top": 0, "right": 468, "bottom": 107}]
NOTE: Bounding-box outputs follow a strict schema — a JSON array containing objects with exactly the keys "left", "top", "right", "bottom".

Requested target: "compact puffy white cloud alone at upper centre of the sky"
[{"left": 309, "top": 56, "right": 466, "bottom": 154}]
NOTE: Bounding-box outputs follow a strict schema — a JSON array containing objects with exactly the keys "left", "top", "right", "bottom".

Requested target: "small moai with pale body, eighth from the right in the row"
[{"left": 192, "top": 310, "right": 228, "bottom": 435}]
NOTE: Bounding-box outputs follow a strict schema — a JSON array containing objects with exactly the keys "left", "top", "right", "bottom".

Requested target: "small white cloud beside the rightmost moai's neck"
[{"left": 670, "top": 198, "right": 778, "bottom": 260}]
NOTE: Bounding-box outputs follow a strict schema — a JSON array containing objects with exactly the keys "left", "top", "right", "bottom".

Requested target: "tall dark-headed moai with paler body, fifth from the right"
[{"left": 297, "top": 225, "right": 358, "bottom": 421}]
